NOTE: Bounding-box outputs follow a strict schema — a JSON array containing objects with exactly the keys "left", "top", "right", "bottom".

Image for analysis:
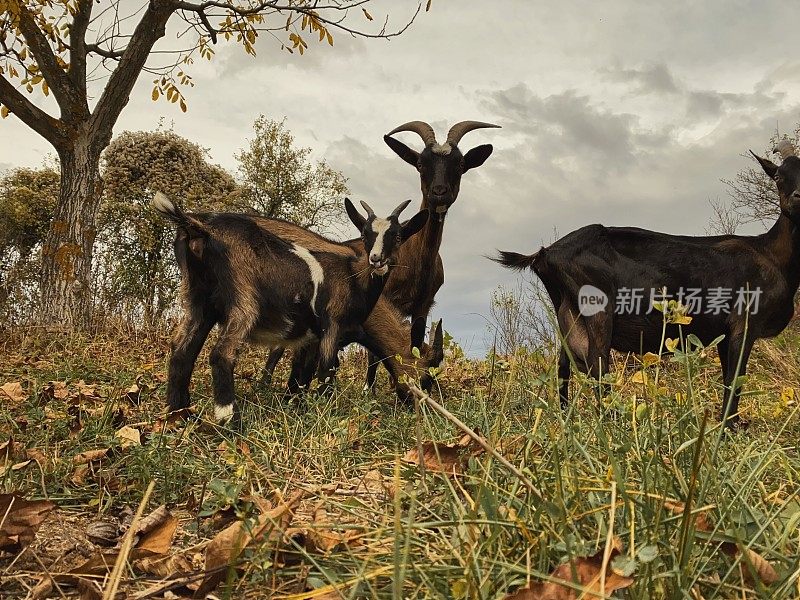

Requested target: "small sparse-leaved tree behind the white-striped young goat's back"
[{"left": 236, "top": 115, "right": 349, "bottom": 230}]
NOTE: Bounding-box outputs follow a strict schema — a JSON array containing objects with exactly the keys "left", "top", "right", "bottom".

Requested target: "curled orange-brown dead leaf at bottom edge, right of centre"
[{"left": 503, "top": 538, "right": 634, "bottom": 600}]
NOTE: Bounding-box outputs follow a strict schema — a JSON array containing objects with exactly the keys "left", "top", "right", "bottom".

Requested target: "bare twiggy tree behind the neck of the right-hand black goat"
[{"left": 709, "top": 125, "right": 800, "bottom": 234}]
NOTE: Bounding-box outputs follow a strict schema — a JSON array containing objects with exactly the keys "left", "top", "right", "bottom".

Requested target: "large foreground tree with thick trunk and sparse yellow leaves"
[{"left": 0, "top": 0, "right": 420, "bottom": 326}]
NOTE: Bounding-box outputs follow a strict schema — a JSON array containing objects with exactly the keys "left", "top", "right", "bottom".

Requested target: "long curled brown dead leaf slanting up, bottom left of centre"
[{"left": 195, "top": 490, "right": 305, "bottom": 598}]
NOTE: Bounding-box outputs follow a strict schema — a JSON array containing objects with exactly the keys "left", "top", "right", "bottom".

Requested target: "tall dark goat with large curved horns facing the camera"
[{"left": 262, "top": 121, "right": 499, "bottom": 389}]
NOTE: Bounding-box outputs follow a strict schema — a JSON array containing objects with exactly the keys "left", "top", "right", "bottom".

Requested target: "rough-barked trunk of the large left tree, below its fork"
[{"left": 40, "top": 128, "right": 102, "bottom": 328}]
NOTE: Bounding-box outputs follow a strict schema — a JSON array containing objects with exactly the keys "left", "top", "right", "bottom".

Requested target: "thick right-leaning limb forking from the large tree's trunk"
[{"left": 92, "top": 0, "right": 175, "bottom": 147}]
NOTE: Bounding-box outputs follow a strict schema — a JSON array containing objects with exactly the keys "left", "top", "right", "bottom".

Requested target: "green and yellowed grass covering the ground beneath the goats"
[{"left": 0, "top": 331, "right": 800, "bottom": 599}]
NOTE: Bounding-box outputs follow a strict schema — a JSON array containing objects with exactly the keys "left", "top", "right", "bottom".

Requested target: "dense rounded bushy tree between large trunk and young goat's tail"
[{"left": 98, "top": 131, "right": 237, "bottom": 326}]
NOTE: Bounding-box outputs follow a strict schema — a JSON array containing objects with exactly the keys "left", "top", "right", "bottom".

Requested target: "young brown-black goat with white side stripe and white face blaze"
[{"left": 153, "top": 193, "right": 428, "bottom": 422}]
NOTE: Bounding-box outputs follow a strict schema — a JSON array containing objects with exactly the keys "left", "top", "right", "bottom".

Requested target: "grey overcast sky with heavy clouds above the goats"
[{"left": 0, "top": 0, "right": 800, "bottom": 354}]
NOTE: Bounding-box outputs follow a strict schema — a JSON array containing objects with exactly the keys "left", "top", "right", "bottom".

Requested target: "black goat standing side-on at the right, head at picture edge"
[{"left": 493, "top": 141, "right": 800, "bottom": 427}]
